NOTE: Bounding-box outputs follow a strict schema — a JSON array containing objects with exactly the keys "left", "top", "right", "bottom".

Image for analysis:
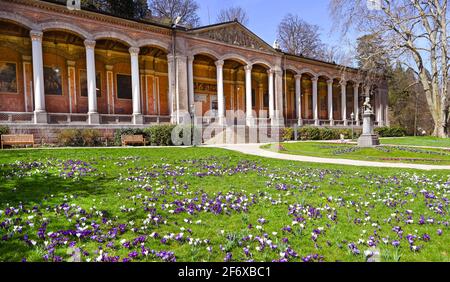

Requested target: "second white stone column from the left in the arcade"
[{"left": 84, "top": 40, "right": 100, "bottom": 124}]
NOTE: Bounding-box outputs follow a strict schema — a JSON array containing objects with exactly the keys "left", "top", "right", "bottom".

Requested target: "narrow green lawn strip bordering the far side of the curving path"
[{"left": 262, "top": 142, "right": 450, "bottom": 165}]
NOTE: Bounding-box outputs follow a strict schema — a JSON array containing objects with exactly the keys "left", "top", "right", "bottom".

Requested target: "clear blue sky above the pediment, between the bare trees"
[{"left": 197, "top": 0, "right": 356, "bottom": 48}]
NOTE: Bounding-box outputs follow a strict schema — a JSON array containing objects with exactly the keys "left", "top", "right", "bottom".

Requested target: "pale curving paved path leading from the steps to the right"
[{"left": 209, "top": 144, "right": 450, "bottom": 170}]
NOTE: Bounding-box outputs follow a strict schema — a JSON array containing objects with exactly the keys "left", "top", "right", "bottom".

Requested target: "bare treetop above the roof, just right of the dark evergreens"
[{"left": 149, "top": 0, "right": 200, "bottom": 27}]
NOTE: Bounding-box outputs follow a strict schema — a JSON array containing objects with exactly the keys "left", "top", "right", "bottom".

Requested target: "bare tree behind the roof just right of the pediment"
[{"left": 277, "top": 14, "right": 325, "bottom": 59}]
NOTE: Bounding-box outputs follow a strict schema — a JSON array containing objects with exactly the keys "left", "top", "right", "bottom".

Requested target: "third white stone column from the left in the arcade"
[{"left": 129, "top": 47, "right": 144, "bottom": 124}]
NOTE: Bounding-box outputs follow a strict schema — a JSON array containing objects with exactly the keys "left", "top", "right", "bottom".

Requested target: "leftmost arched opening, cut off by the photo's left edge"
[{"left": 0, "top": 20, "right": 33, "bottom": 114}]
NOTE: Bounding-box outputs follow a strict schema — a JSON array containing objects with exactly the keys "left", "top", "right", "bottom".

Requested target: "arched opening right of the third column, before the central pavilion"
[{"left": 139, "top": 46, "right": 170, "bottom": 116}]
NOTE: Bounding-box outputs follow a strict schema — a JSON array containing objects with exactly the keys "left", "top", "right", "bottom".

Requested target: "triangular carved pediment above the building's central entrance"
[{"left": 190, "top": 22, "right": 275, "bottom": 52}]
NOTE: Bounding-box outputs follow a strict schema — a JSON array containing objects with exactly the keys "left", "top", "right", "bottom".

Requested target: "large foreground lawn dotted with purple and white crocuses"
[{"left": 0, "top": 148, "right": 450, "bottom": 262}]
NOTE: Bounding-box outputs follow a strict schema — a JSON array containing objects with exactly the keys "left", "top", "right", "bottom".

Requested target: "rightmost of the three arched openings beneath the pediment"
[{"left": 252, "top": 64, "right": 269, "bottom": 118}]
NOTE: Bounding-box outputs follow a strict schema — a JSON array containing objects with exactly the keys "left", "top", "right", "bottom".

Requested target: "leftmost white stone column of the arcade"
[{"left": 30, "top": 30, "right": 47, "bottom": 123}]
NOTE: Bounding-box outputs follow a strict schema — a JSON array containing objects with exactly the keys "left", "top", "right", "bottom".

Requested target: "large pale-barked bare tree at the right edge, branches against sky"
[{"left": 330, "top": 0, "right": 450, "bottom": 137}]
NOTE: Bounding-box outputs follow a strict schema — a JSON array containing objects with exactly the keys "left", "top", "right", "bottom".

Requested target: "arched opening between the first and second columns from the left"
[{"left": 42, "top": 30, "right": 87, "bottom": 115}]
